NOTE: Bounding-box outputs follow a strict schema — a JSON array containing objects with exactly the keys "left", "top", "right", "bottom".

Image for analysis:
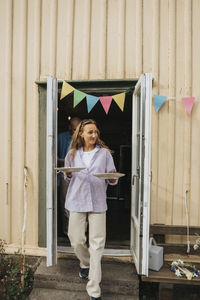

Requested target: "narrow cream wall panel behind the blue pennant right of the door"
[{"left": 157, "top": 0, "right": 169, "bottom": 223}]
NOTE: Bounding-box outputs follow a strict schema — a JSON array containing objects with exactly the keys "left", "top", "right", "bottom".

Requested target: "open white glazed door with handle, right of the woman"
[{"left": 131, "top": 74, "right": 152, "bottom": 276}]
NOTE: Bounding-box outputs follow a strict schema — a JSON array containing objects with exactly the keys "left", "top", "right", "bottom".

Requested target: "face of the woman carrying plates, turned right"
[{"left": 80, "top": 124, "right": 98, "bottom": 147}]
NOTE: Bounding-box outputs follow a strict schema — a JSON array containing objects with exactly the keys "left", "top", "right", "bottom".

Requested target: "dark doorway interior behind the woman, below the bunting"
[{"left": 57, "top": 80, "right": 137, "bottom": 249}]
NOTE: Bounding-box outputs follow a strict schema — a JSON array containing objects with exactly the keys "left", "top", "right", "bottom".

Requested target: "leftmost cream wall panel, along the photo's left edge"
[{"left": 0, "top": 1, "right": 12, "bottom": 243}]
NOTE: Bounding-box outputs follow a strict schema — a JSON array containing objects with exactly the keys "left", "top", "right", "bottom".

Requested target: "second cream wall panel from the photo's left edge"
[{"left": 11, "top": 0, "right": 27, "bottom": 243}]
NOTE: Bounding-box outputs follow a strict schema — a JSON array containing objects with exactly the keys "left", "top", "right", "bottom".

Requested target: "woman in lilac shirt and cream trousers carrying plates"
[{"left": 65, "top": 119, "right": 117, "bottom": 300}]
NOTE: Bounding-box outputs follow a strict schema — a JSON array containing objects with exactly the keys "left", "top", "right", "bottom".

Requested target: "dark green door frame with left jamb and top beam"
[{"left": 35, "top": 78, "right": 138, "bottom": 251}]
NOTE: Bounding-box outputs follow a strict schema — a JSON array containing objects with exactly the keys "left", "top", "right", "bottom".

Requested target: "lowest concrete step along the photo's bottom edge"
[{"left": 29, "top": 288, "right": 138, "bottom": 300}]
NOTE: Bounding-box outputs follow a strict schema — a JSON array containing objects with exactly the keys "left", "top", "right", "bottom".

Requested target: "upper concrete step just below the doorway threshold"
[{"left": 30, "top": 258, "right": 139, "bottom": 300}]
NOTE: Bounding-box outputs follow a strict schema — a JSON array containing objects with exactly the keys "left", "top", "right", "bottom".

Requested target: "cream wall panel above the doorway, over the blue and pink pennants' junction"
[{"left": 89, "top": 0, "right": 107, "bottom": 79}]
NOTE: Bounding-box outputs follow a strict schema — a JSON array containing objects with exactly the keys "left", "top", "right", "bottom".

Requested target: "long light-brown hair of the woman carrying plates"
[{"left": 70, "top": 119, "right": 112, "bottom": 161}]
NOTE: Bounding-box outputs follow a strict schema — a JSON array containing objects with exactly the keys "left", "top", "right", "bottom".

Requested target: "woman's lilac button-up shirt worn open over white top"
[{"left": 65, "top": 145, "right": 117, "bottom": 212}]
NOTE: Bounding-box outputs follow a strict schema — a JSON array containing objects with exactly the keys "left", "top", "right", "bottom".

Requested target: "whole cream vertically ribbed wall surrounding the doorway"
[{"left": 0, "top": 0, "right": 200, "bottom": 245}]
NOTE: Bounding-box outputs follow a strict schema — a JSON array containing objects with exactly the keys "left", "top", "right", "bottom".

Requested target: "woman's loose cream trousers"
[{"left": 68, "top": 212, "right": 106, "bottom": 298}]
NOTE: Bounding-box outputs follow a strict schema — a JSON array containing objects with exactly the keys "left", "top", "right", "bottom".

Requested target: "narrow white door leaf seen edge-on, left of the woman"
[{"left": 46, "top": 77, "right": 58, "bottom": 266}]
